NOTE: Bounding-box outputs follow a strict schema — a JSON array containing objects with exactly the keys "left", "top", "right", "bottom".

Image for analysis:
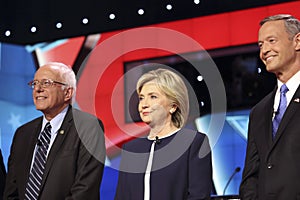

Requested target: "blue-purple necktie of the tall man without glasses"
[{"left": 273, "top": 84, "right": 289, "bottom": 138}]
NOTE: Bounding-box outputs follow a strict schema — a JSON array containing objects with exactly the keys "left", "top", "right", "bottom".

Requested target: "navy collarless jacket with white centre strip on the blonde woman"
[{"left": 115, "top": 129, "right": 212, "bottom": 200}]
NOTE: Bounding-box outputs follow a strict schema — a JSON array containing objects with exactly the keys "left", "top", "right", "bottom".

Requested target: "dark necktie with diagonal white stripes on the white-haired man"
[{"left": 25, "top": 122, "right": 51, "bottom": 200}]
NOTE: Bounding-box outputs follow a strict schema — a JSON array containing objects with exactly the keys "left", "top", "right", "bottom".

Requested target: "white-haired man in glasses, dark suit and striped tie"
[{"left": 4, "top": 63, "right": 105, "bottom": 200}]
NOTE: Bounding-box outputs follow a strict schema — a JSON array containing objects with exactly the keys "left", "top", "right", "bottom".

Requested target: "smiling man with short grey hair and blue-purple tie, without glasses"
[{"left": 240, "top": 15, "right": 300, "bottom": 200}]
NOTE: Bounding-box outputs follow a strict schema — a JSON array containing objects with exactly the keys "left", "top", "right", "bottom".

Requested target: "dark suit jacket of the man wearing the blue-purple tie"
[{"left": 240, "top": 87, "right": 300, "bottom": 200}]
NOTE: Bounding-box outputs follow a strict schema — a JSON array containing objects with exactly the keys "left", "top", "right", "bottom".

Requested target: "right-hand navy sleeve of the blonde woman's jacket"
[{"left": 187, "top": 133, "right": 212, "bottom": 200}]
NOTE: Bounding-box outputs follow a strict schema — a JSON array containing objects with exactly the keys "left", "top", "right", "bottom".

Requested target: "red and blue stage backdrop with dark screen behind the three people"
[{"left": 0, "top": 1, "right": 300, "bottom": 200}]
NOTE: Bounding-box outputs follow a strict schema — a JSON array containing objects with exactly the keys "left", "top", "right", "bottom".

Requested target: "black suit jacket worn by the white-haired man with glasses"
[{"left": 4, "top": 106, "right": 105, "bottom": 200}]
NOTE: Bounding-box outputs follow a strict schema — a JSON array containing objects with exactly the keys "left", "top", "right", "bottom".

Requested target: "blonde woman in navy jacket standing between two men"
[{"left": 115, "top": 69, "right": 212, "bottom": 200}]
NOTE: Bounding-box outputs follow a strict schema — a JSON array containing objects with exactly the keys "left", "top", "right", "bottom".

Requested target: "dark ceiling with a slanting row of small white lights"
[{"left": 0, "top": 0, "right": 291, "bottom": 44}]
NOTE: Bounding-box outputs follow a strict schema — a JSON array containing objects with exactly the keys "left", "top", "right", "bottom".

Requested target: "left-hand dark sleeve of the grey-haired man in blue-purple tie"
[{"left": 239, "top": 112, "right": 260, "bottom": 200}]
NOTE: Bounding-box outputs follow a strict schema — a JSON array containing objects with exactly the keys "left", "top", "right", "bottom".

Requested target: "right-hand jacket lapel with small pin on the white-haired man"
[{"left": 41, "top": 106, "right": 73, "bottom": 188}]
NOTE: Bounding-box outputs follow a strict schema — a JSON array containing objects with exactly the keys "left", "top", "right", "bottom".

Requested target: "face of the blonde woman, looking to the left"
[{"left": 138, "top": 82, "right": 172, "bottom": 127}]
